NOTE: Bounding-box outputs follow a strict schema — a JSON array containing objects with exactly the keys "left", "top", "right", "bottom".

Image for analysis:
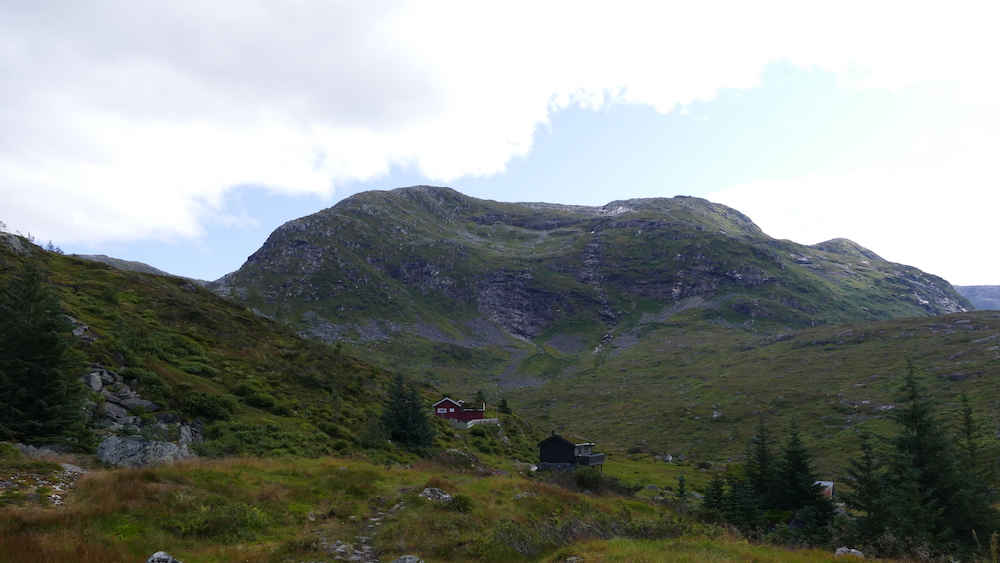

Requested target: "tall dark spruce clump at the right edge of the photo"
[{"left": 844, "top": 364, "right": 1000, "bottom": 556}]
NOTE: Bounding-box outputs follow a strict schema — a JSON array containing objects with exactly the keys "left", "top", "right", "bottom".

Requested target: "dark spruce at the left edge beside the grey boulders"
[{"left": 0, "top": 265, "right": 88, "bottom": 447}]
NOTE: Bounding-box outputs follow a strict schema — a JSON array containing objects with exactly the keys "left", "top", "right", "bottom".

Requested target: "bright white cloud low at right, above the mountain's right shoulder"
[{"left": 707, "top": 115, "right": 1000, "bottom": 285}]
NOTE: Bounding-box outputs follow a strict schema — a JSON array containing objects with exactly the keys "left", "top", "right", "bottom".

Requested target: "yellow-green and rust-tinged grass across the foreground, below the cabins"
[{"left": 0, "top": 454, "right": 892, "bottom": 563}]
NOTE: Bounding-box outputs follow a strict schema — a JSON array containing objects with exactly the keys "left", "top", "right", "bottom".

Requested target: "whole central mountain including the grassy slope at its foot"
[{"left": 211, "top": 187, "right": 976, "bottom": 459}]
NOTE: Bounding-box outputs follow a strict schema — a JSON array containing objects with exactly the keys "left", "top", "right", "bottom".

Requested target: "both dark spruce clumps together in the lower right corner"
[{"left": 701, "top": 365, "right": 1000, "bottom": 558}]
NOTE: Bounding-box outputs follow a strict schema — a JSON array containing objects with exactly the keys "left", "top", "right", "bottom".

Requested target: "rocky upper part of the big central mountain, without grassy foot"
[{"left": 213, "top": 186, "right": 971, "bottom": 356}]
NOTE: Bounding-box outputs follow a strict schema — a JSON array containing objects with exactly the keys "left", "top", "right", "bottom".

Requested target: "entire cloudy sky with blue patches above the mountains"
[{"left": 0, "top": 0, "right": 1000, "bottom": 285}]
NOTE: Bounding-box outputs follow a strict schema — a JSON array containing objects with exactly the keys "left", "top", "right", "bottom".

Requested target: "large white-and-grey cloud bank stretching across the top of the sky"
[{"left": 0, "top": 0, "right": 1000, "bottom": 247}]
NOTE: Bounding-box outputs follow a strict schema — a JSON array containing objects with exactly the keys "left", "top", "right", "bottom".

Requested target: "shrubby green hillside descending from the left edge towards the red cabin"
[{"left": 0, "top": 231, "right": 388, "bottom": 455}]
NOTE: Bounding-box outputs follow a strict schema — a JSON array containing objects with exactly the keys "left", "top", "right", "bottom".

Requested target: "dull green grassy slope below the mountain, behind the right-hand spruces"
[{"left": 507, "top": 311, "right": 1000, "bottom": 475}]
